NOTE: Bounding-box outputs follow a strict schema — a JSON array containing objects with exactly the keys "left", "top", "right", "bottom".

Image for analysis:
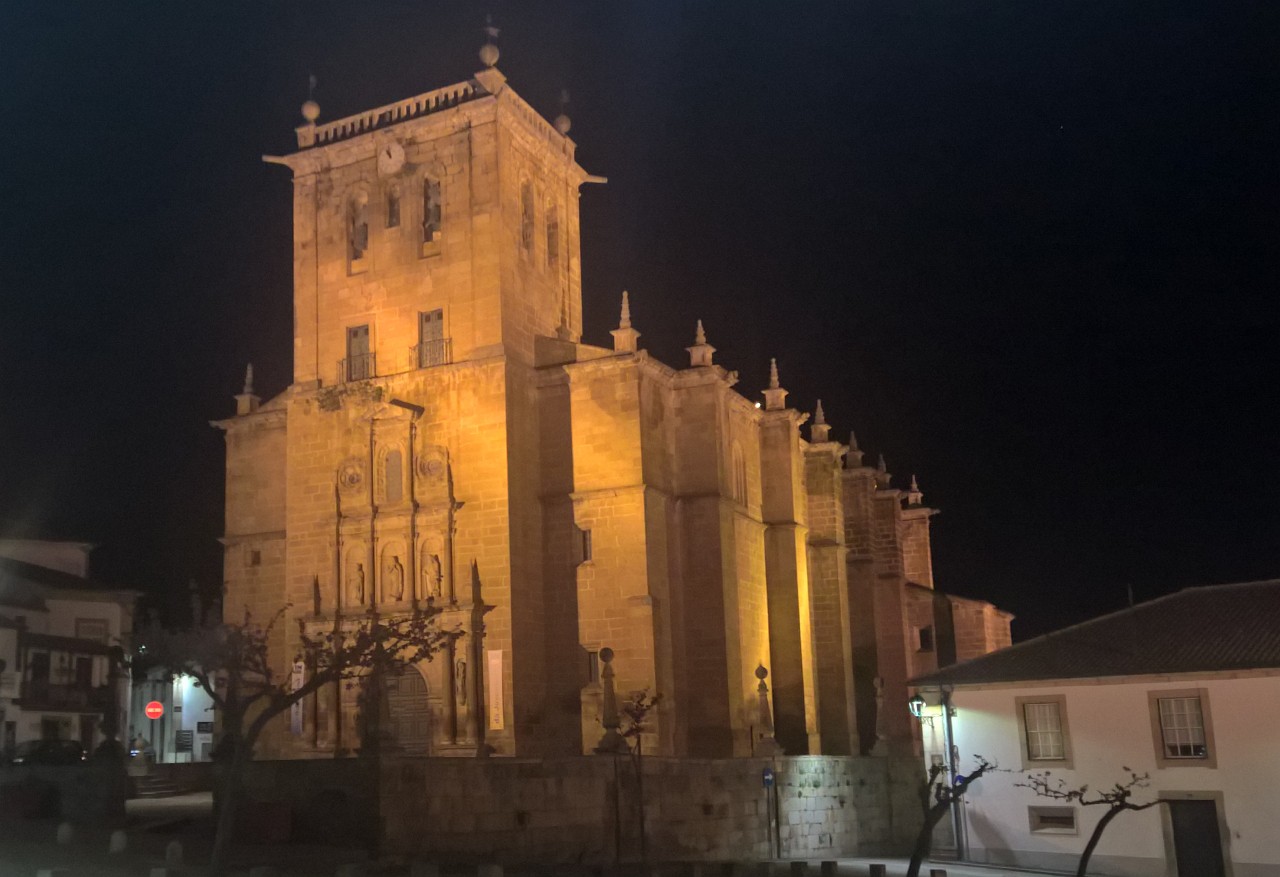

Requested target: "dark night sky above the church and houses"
[{"left": 0, "top": 0, "right": 1280, "bottom": 638}]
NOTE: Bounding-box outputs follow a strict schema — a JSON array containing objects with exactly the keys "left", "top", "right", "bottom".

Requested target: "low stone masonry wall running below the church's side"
[{"left": 381, "top": 757, "right": 919, "bottom": 862}]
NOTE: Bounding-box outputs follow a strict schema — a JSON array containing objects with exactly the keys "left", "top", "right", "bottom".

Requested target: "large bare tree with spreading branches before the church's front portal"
[{"left": 137, "top": 606, "right": 457, "bottom": 874}]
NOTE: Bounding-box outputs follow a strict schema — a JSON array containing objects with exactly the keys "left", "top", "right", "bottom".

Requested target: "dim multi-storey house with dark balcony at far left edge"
[{"left": 0, "top": 539, "right": 138, "bottom": 752}]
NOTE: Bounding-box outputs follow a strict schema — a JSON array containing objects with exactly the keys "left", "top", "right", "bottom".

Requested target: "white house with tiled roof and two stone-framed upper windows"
[{"left": 914, "top": 581, "right": 1280, "bottom": 877}]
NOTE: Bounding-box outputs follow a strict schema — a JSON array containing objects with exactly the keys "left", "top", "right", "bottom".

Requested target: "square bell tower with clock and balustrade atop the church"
[{"left": 265, "top": 34, "right": 594, "bottom": 385}]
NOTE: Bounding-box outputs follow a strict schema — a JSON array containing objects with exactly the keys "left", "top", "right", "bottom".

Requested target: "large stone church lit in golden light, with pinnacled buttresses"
[{"left": 216, "top": 37, "right": 1010, "bottom": 757}]
